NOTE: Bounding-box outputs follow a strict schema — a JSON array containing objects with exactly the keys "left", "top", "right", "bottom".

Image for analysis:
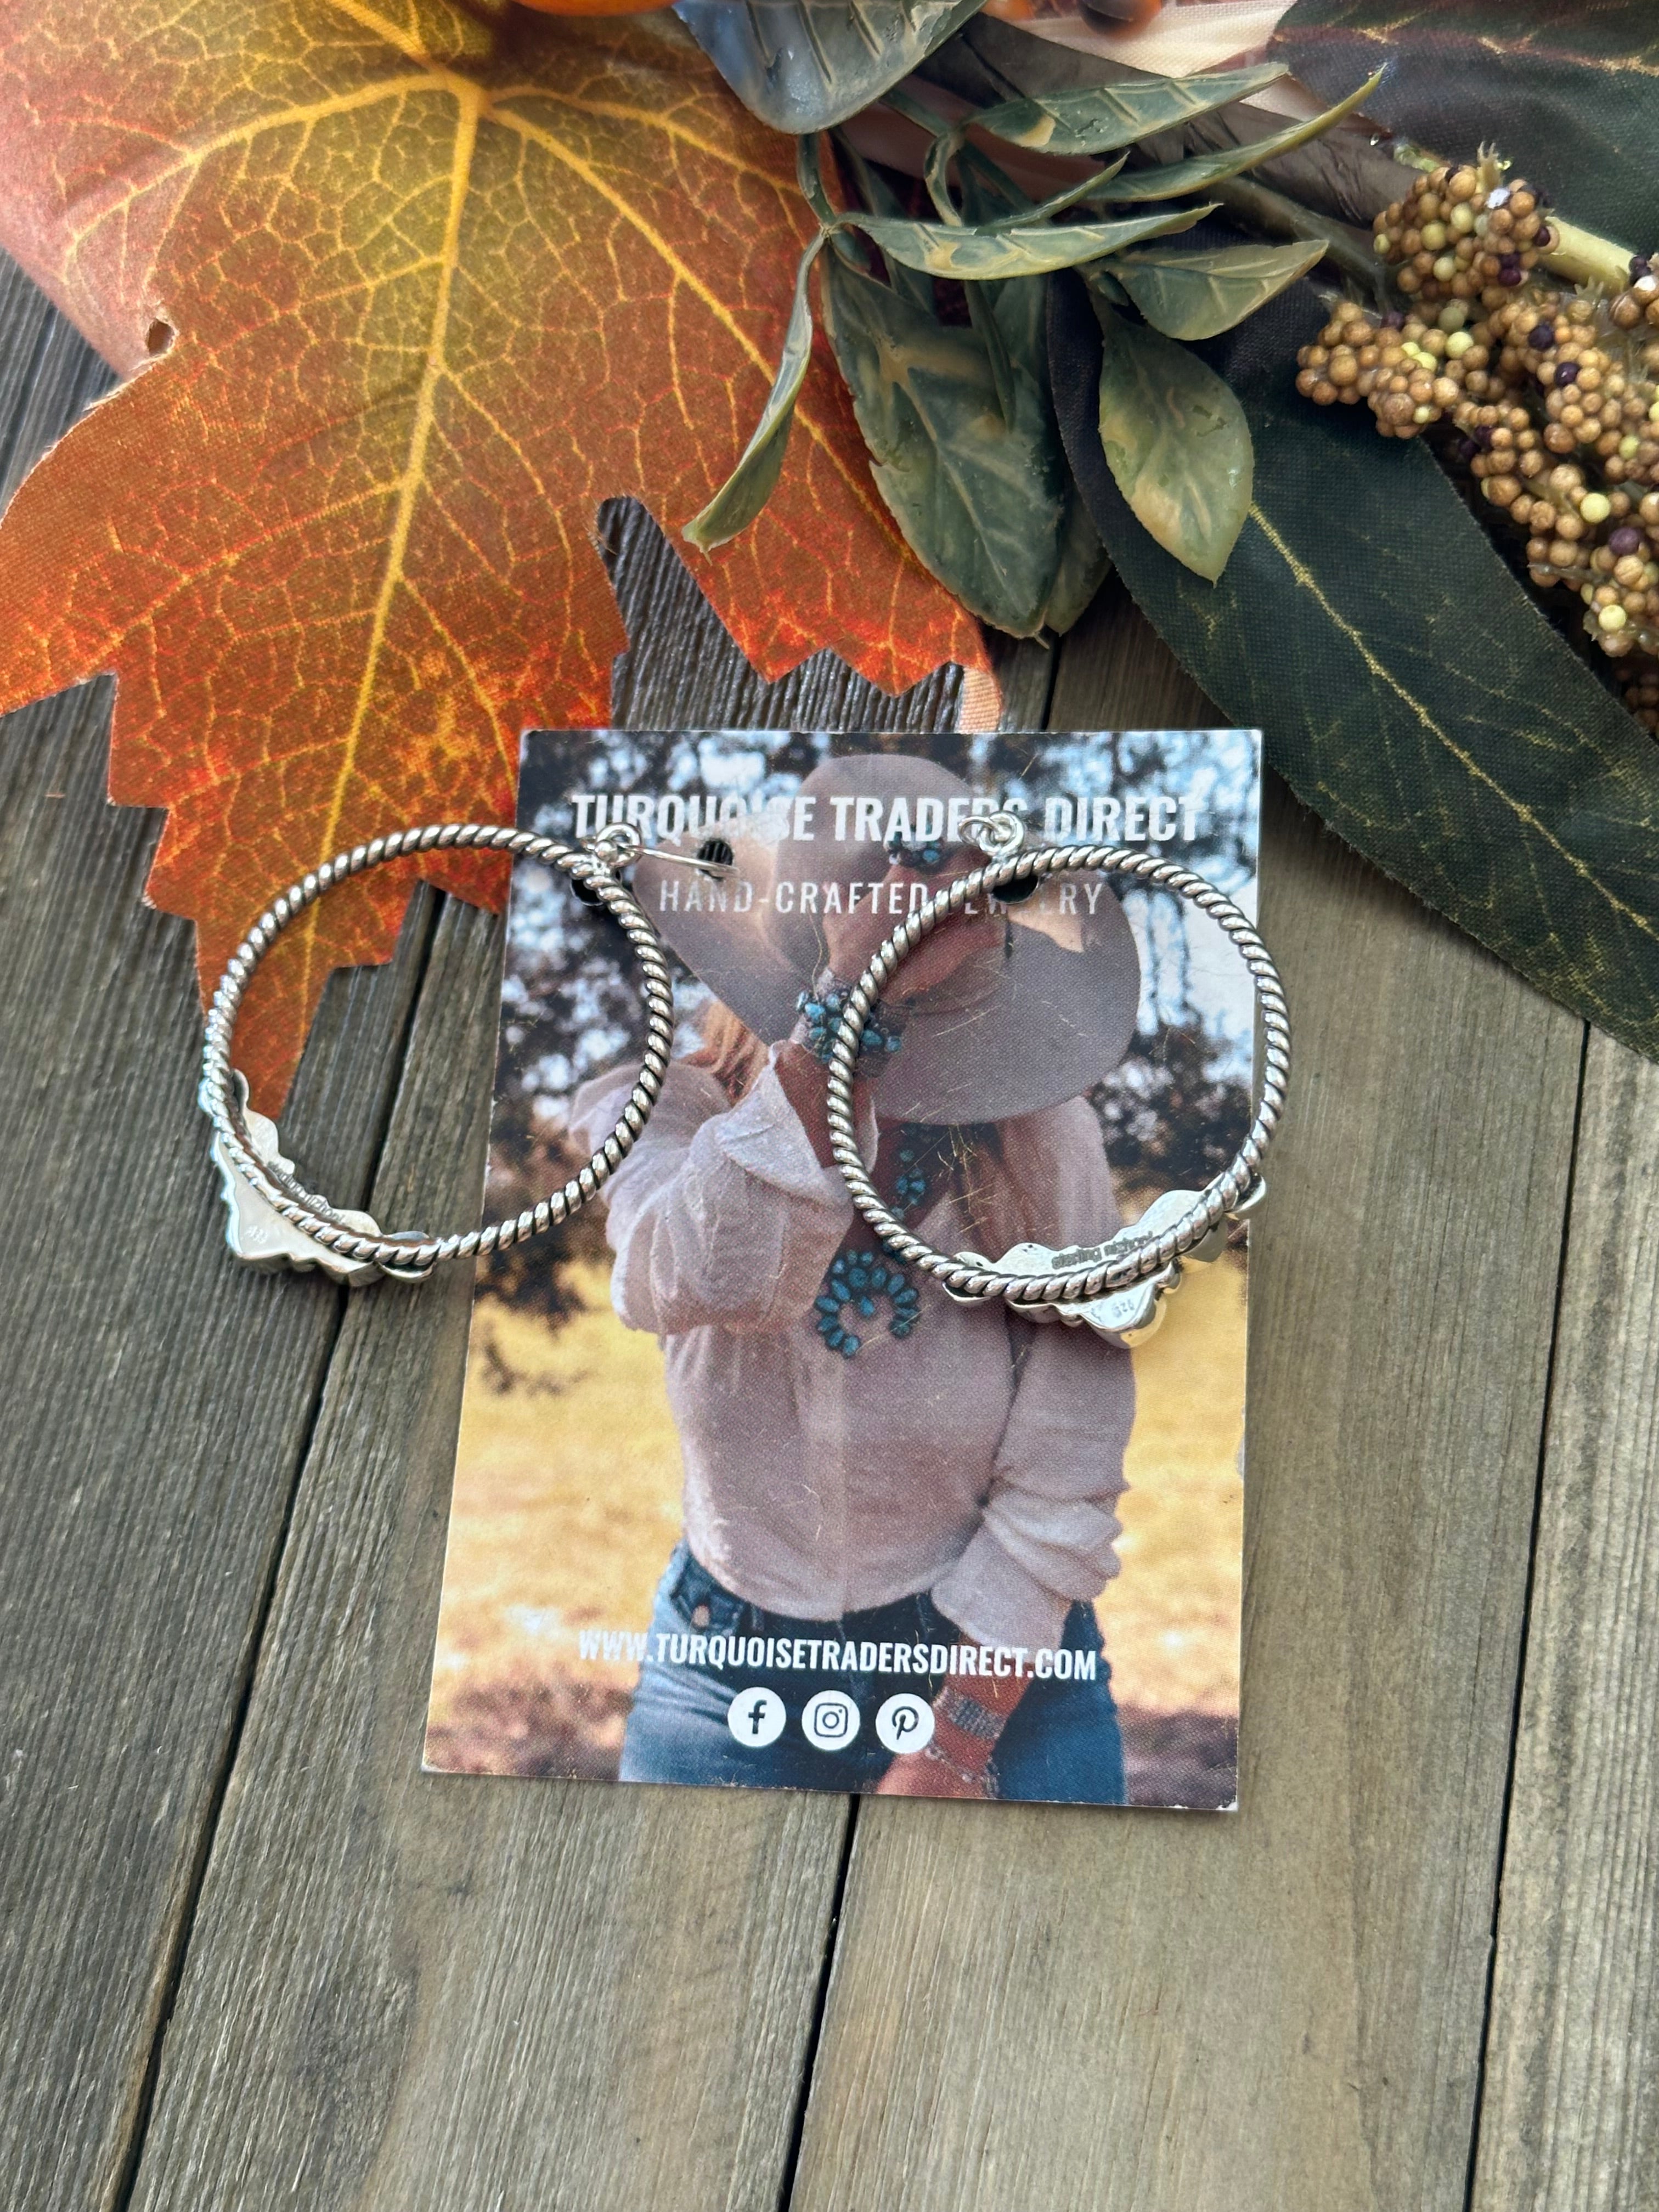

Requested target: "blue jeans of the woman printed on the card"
[{"left": 622, "top": 1544, "right": 1124, "bottom": 1805}]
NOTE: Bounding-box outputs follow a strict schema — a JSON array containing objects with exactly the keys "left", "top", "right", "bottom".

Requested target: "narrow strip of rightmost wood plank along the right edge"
[{"left": 1473, "top": 1037, "right": 1659, "bottom": 2212}]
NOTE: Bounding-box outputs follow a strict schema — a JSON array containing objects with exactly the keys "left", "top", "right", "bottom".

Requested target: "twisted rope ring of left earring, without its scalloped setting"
[{"left": 201, "top": 823, "right": 675, "bottom": 1276}]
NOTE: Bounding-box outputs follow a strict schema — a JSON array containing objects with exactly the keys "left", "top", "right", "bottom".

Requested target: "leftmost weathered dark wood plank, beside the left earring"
[{"left": 0, "top": 274, "right": 444, "bottom": 2212}]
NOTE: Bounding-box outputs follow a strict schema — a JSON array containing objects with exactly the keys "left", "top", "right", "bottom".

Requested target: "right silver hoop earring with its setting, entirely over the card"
[{"left": 827, "top": 812, "right": 1290, "bottom": 1347}]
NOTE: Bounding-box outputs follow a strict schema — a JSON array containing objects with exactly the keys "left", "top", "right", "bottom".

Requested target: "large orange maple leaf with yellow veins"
[{"left": 0, "top": 0, "right": 984, "bottom": 1104}]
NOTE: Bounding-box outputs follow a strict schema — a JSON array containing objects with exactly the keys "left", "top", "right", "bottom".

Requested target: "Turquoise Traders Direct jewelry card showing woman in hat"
[{"left": 427, "top": 730, "right": 1261, "bottom": 1809}]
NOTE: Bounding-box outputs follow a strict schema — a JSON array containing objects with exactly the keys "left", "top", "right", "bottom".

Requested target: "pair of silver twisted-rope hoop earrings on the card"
[{"left": 199, "top": 812, "right": 1290, "bottom": 1345}]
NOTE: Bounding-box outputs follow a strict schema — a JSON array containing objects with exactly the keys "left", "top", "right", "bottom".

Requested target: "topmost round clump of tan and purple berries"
[{"left": 1372, "top": 155, "right": 1553, "bottom": 307}]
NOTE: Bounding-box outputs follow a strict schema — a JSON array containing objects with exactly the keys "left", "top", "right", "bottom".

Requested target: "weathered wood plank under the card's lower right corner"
[{"left": 789, "top": 600, "right": 1579, "bottom": 2212}]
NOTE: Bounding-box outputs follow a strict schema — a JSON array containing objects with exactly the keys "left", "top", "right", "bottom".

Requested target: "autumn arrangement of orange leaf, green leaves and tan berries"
[{"left": 0, "top": 0, "right": 1659, "bottom": 1106}]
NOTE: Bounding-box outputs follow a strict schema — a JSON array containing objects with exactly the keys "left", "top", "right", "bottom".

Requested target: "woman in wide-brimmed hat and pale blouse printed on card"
[{"left": 571, "top": 754, "right": 1142, "bottom": 1803}]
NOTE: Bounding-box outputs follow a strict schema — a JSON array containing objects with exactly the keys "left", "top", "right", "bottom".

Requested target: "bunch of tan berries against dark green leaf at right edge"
[{"left": 1296, "top": 163, "right": 1659, "bottom": 730}]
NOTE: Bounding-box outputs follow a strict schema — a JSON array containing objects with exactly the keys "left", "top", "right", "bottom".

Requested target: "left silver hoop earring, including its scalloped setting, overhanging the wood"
[{"left": 197, "top": 823, "right": 725, "bottom": 1285}]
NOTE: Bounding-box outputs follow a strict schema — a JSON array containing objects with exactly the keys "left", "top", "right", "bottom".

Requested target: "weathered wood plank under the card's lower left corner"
[{"left": 114, "top": 517, "right": 953, "bottom": 2212}]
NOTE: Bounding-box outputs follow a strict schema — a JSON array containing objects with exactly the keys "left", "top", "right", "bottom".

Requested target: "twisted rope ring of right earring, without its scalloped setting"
[{"left": 827, "top": 836, "right": 1290, "bottom": 1305}]
